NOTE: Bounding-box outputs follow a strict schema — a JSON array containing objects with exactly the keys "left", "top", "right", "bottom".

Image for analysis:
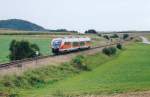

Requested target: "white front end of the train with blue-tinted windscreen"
[{"left": 51, "top": 38, "right": 62, "bottom": 54}]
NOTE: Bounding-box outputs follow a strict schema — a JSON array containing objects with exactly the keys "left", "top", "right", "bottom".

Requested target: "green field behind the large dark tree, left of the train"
[{"left": 0, "top": 35, "right": 51, "bottom": 63}]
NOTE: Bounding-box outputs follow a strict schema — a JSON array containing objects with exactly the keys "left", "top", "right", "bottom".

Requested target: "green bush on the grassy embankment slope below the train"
[{"left": 72, "top": 55, "right": 89, "bottom": 70}]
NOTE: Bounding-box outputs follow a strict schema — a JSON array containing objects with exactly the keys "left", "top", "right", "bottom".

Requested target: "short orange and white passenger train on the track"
[{"left": 51, "top": 37, "right": 91, "bottom": 54}]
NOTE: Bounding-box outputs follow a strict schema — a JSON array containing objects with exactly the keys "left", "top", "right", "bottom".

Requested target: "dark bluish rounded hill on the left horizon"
[{"left": 0, "top": 19, "right": 45, "bottom": 31}]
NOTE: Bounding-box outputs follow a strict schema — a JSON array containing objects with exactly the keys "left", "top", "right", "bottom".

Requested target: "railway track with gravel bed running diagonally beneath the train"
[{"left": 0, "top": 42, "right": 123, "bottom": 70}]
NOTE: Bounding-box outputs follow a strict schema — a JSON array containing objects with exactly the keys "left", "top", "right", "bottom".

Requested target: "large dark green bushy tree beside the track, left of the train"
[{"left": 9, "top": 40, "right": 40, "bottom": 60}]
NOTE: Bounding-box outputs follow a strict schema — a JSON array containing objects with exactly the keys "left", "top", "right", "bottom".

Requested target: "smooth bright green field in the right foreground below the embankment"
[{"left": 21, "top": 43, "right": 150, "bottom": 97}]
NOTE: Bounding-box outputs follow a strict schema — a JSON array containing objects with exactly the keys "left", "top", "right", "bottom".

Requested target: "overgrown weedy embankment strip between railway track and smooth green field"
[{"left": 0, "top": 53, "right": 116, "bottom": 97}]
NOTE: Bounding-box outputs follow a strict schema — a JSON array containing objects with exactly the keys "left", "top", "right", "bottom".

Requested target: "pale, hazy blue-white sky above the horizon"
[{"left": 0, "top": 0, "right": 150, "bottom": 31}]
